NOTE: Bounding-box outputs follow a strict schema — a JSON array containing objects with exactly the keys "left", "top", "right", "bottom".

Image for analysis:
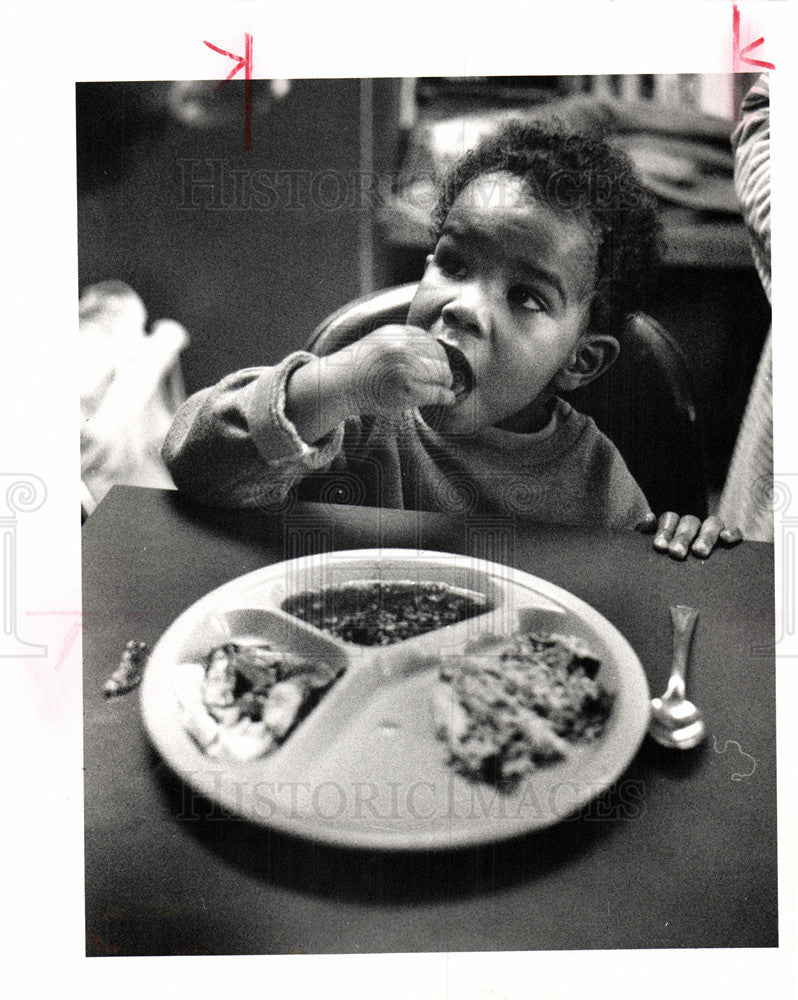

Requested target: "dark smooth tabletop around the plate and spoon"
[{"left": 83, "top": 487, "right": 778, "bottom": 955}]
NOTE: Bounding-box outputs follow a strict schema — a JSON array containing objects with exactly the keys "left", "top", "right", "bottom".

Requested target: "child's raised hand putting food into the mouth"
[{"left": 338, "top": 324, "right": 455, "bottom": 416}]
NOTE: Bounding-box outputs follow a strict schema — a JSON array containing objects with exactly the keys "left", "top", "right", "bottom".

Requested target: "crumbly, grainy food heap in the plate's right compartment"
[{"left": 432, "top": 632, "right": 614, "bottom": 786}]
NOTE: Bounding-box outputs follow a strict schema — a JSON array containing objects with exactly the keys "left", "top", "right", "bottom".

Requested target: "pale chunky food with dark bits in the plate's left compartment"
[{"left": 175, "top": 642, "right": 340, "bottom": 760}]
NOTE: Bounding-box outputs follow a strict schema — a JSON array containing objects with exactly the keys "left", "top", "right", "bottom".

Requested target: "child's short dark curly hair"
[{"left": 433, "top": 120, "right": 660, "bottom": 336}]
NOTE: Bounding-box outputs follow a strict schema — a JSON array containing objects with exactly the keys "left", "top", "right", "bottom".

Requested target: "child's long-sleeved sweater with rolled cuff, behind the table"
[{"left": 163, "top": 351, "right": 649, "bottom": 528}]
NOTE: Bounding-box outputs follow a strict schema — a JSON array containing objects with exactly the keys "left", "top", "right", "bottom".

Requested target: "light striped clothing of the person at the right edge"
[{"left": 718, "top": 73, "right": 773, "bottom": 541}]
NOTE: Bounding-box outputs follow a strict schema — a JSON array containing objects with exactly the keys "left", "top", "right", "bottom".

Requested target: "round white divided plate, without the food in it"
[{"left": 141, "top": 549, "right": 650, "bottom": 850}]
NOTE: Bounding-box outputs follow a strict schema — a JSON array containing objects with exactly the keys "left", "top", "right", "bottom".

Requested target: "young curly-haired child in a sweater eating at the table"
[{"left": 163, "top": 122, "right": 736, "bottom": 558}]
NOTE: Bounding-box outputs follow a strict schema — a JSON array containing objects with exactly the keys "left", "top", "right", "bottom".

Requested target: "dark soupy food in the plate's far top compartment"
[{"left": 281, "top": 580, "right": 491, "bottom": 646}]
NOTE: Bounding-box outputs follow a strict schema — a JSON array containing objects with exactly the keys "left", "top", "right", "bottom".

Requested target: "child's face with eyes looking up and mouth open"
[{"left": 407, "top": 172, "right": 597, "bottom": 433}]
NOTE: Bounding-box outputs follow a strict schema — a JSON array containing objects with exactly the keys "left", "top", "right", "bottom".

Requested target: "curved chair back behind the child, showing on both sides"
[{"left": 307, "top": 284, "right": 707, "bottom": 517}]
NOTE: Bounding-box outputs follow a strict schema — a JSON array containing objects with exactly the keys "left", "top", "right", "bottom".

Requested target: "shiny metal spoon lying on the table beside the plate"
[{"left": 648, "top": 604, "right": 707, "bottom": 750}]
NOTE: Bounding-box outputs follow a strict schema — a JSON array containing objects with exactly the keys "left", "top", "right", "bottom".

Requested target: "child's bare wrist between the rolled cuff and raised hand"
[{"left": 285, "top": 358, "right": 358, "bottom": 444}]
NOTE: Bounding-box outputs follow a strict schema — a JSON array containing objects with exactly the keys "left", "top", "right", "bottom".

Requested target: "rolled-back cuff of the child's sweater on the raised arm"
[{"left": 246, "top": 351, "right": 344, "bottom": 469}]
